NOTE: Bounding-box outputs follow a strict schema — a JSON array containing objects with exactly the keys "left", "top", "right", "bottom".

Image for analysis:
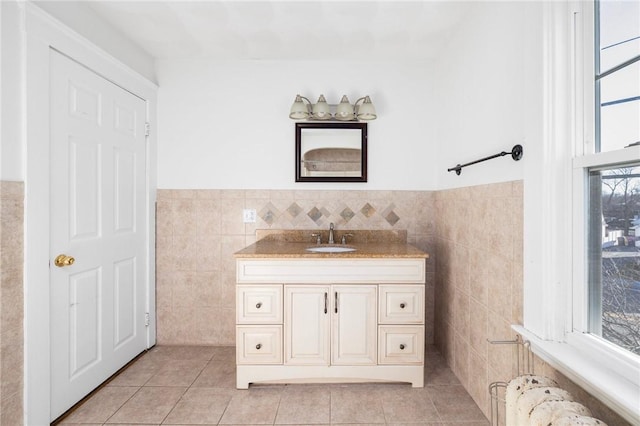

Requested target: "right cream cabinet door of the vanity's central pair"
[{"left": 331, "top": 285, "right": 378, "bottom": 365}]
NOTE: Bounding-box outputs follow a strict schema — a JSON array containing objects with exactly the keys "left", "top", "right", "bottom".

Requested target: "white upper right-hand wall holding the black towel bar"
[{"left": 434, "top": 2, "right": 542, "bottom": 189}]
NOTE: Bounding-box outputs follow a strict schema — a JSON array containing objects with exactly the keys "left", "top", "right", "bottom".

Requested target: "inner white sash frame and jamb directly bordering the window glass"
[{"left": 567, "top": 1, "right": 640, "bottom": 362}]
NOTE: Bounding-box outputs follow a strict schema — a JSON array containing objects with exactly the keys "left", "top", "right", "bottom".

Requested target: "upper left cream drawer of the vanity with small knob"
[{"left": 236, "top": 285, "right": 282, "bottom": 324}]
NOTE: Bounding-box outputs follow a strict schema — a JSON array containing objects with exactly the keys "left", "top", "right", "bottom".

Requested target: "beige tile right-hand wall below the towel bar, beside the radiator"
[{"left": 434, "top": 181, "right": 628, "bottom": 426}]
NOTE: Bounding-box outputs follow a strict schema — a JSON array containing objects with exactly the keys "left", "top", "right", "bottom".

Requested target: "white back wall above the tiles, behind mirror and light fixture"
[{"left": 157, "top": 61, "right": 438, "bottom": 190}]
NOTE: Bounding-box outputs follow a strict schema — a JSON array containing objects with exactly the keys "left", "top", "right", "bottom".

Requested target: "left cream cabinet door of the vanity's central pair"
[{"left": 284, "top": 285, "right": 331, "bottom": 365}]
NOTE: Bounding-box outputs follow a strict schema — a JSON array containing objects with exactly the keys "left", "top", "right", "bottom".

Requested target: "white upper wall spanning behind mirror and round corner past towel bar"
[{"left": 157, "top": 2, "right": 542, "bottom": 190}]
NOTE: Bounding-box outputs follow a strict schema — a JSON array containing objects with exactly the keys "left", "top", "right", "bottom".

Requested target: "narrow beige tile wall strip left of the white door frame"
[{"left": 0, "top": 181, "right": 24, "bottom": 425}]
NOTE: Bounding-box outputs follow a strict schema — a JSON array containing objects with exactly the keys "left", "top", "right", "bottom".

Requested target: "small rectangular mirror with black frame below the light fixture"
[{"left": 296, "top": 122, "right": 367, "bottom": 182}]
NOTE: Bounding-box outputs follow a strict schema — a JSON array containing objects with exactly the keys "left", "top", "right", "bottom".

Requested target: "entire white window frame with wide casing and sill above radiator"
[{"left": 513, "top": 0, "right": 640, "bottom": 424}]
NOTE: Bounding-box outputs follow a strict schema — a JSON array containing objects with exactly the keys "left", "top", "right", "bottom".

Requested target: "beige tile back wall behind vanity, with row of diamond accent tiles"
[{"left": 156, "top": 190, "right": 435, "bottom": 345}]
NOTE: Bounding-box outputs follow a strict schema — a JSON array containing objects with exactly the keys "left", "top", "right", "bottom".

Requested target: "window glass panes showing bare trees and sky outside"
[{"left": 582, "top": 0, "right": 640, "bottom": 355}]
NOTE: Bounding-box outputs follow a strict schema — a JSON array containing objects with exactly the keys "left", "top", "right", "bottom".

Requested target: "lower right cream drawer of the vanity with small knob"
[{"left": 378, "top": 325, "right": 424, "bottom": 364}]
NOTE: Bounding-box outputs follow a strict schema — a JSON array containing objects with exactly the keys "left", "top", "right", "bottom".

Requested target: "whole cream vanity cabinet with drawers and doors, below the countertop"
[{"left": 236, "top": 258, "right": 425, "bottom": 389}]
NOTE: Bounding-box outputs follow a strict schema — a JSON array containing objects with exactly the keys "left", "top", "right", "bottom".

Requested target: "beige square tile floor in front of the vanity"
[{"left": 58, "top": 346, "right": 489, "bottom": 426}]
